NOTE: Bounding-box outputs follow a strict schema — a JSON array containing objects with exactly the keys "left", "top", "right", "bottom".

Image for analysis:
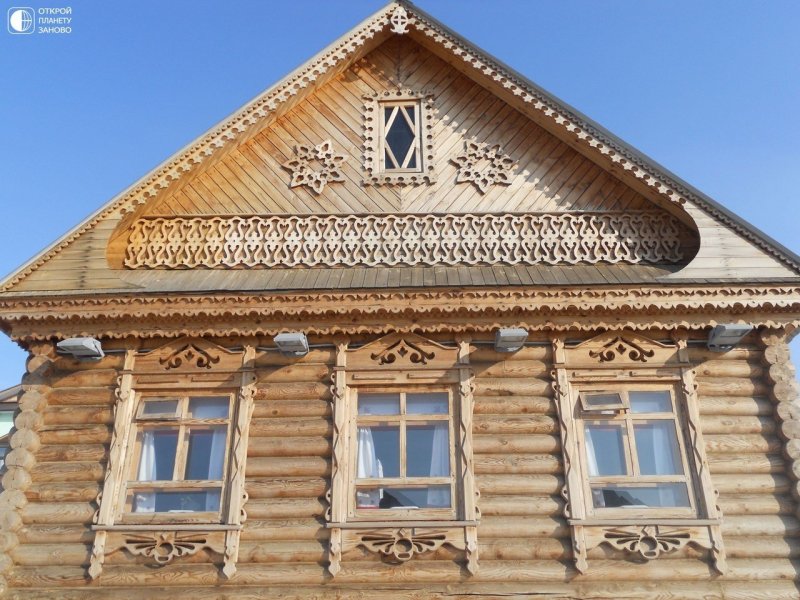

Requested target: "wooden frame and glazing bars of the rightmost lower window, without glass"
[{"left": 575, "top": 380, "right": 698, "bottom": 519}]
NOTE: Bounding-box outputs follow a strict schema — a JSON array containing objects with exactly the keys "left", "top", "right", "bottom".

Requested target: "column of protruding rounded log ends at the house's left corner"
[{"left": 0, "top": 342, "right": 55, "bottom": 595}]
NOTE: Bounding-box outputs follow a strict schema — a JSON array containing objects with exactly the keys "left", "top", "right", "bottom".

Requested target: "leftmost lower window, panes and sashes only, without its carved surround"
[{"left": 123, "top": 395, "right": 231, "bottom": 521}]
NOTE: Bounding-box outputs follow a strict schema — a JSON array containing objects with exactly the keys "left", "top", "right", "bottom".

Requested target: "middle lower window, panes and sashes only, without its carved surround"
[{"left": 351, "top": 390, "right": 456, "bottom": 519}]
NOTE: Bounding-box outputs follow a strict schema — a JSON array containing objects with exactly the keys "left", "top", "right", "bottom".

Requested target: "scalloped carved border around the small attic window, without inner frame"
[{"left": 364, "top": 89, "right": 436, "bottom": 185}]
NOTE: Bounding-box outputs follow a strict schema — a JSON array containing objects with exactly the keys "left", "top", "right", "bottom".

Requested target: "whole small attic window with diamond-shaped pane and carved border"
[{"left": 364, "top": 89, "right": 436, "bottom": 185}]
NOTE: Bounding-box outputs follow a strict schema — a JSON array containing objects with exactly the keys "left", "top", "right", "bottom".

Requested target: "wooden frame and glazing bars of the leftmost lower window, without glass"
[{"left": 115, "top": 388, "right": 235, "bottom": 524}]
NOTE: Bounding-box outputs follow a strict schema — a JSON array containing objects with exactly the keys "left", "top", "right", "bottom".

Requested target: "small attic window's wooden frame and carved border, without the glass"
[{"left": 363, "top": 90, "right": 436, "bottom": 185}]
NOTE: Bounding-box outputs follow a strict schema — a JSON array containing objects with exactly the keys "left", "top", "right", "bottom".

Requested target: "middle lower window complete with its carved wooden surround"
[{"left": 326, "top": 333, "right": 480, "bottom": 576}]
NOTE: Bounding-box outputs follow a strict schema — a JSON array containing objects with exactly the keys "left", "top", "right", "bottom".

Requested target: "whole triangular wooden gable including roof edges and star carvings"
[{"left": 3, "top": 2, "right": 800, "bottom": 293}]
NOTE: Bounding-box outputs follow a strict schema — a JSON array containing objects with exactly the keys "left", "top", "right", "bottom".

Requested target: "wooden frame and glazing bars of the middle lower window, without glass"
[{"left": 347, "top": 384, "right": 460, "bottom": 523}]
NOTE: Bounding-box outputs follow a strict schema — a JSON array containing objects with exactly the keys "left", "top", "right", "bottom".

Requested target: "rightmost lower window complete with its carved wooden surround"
[{"left": 552, "top": 332, "right": 727, "bottom": 573}]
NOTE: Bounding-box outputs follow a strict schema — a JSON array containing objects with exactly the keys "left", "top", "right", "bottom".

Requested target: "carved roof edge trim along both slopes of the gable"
[{"left": 0, "top": 0, "right": 800, "bottom": 292}]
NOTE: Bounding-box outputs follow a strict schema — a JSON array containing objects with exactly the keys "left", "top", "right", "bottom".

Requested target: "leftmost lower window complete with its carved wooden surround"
[{"left": 88, "top": 339, "right": 255, "bottom": 579}]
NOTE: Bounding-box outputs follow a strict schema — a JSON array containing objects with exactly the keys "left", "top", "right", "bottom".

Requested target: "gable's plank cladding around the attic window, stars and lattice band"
[{"left": 6, "top": 0, "right": 797, "bottom": 292}]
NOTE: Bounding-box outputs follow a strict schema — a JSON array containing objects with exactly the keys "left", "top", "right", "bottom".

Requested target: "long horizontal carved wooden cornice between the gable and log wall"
[{"left": 6, "top": 285, "right": 800, "bottom": 342}]
